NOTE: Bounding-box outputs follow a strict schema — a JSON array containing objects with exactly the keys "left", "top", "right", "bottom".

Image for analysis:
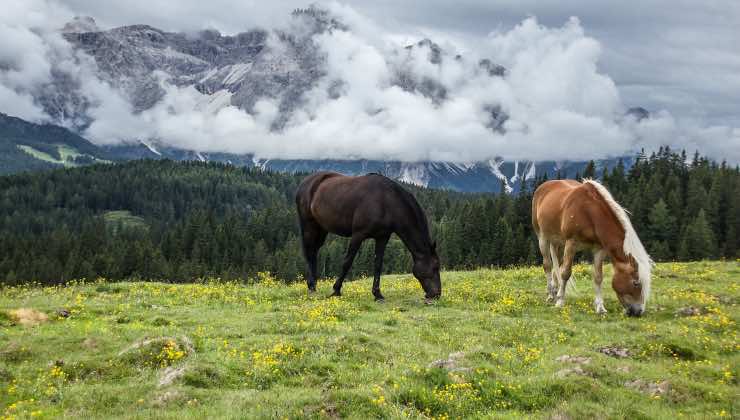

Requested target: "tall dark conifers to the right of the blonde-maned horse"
[{"left": 601, "top": 147, "right": 740, "bottom": 261}]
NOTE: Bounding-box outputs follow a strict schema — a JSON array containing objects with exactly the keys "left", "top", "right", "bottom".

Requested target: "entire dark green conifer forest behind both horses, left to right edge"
[{"left": 0, "top": 149, "right": 740, "bottom": 284}]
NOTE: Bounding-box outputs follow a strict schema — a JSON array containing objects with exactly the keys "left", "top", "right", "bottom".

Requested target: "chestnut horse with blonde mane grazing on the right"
[{"left": 532, "top": 180, "right": 653, "bottom": 316}]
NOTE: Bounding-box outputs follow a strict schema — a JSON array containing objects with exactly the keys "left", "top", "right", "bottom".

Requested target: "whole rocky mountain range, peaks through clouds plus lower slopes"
[{"left": 0, "top": 7, "right": 648, "bottom": 192}]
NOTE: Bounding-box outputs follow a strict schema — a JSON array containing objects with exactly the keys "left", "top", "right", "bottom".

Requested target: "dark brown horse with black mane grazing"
[{"left": 296, "top": 172, "right": 442, "bottom": 301}]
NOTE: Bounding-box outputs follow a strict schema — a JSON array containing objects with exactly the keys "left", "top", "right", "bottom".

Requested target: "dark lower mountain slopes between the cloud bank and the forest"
[{"left": 0, "top": 110, "right": 630, "bottom": 192}]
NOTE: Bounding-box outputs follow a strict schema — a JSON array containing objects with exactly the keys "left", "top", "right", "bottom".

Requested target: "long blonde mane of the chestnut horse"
[{"left": 583, "top": 179, "right": 653, "bottom": 305}]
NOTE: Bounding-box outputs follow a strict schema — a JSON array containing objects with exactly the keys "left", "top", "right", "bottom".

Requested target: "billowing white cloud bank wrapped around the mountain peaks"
[{"left": 0, "top": 0, "right": 740, "bottom": 162}]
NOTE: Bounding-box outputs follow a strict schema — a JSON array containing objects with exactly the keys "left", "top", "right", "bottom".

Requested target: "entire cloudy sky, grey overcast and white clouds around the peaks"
[{"left": 0, "top": 0, "right": 740, "bottom": 163}]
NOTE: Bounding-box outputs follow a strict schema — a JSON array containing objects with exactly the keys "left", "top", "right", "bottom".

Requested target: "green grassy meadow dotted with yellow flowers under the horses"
[{"left": 0, "top": 261, "right": 740, "bottom": 419}]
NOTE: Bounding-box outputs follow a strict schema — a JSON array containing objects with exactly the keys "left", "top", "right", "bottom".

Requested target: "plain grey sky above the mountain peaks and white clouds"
[{"left": 61, "top": 0, "right": 740, "bottom": 127}]
